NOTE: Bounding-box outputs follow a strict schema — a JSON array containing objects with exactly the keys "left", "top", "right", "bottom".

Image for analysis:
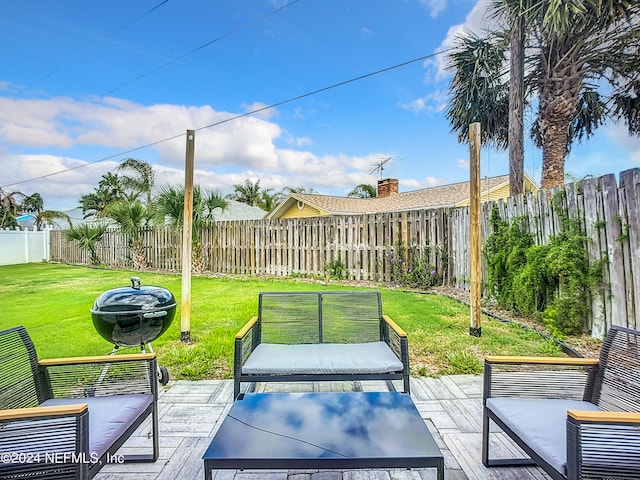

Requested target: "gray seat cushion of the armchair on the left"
[{"left": 41, "top": 394, "right": 153, "bottom": 457}]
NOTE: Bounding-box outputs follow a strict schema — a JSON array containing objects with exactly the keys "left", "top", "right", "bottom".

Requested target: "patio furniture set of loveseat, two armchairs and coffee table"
[{"left": 0, "top": 291, "right": 640, "bottom": 480}]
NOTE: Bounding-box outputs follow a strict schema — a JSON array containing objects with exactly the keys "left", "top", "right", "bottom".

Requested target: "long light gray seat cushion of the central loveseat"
[{"left": 242, "top": 342, "right": 403, "bottom": 375}]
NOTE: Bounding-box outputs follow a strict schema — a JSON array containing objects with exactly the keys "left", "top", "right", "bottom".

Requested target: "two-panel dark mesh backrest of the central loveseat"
[{"left": 258, "top": 290, "right": 382, "bottom": 344}]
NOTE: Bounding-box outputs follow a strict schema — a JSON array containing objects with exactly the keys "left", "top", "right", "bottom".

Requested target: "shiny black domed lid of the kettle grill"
[{"left": 91, "top": 277, "right": 177, "bottom": 315}]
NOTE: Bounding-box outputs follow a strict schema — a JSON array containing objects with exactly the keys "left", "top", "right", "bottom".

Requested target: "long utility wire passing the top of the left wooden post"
[{"left": 0, "top": 48, "right": 454, "bottom": 188}]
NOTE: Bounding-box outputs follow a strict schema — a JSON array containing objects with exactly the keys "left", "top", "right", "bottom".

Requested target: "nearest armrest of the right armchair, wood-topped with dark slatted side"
[{"left": 567, "top": 410, "right": 640, "bottom": 478}]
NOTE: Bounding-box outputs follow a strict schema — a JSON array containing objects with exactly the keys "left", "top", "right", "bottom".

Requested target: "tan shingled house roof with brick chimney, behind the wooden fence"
[{"left": 267, "top": 175, "right": 531, "bottom": 218}]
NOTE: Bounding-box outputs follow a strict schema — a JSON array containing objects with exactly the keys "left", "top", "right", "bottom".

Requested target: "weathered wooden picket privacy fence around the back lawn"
[{"left": 51, "top": 169, "right": 640, "bottom": 337}]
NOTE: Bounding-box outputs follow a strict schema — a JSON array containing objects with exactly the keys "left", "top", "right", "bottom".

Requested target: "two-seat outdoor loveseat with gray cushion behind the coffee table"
[{"left": 233, "top": 290, "right": 409, "bottom": 399}]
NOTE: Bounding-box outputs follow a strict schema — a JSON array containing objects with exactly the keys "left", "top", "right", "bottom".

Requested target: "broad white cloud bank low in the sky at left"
[{"left": 0, "top": 97, "right": 382, "bottom": 210}]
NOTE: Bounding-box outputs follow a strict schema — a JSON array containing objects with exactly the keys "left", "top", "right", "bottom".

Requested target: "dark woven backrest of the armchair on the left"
[{"left": 0, "top": 327, "right": 45, "bottom": 410}]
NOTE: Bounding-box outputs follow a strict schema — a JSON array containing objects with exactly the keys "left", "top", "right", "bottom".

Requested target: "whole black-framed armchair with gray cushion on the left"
[{"left": 0, "top": 327, "right": 158, "bottom": 480}]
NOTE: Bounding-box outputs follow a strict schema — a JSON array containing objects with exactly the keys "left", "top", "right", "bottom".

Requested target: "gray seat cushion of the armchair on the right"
[{"left": 487, "top": 398, "right": 601, "bottom": 475}]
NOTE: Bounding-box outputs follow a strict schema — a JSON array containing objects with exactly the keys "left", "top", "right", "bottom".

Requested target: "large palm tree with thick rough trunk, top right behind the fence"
[{"left": 447, "top": 0, "right": 640, "bottom": 189}]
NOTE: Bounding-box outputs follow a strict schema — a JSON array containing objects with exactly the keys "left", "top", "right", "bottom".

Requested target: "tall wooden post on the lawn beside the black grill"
[{"left": 180, "top": 130, "right": 196, "bottom": 343}]
